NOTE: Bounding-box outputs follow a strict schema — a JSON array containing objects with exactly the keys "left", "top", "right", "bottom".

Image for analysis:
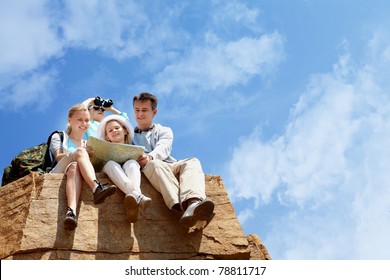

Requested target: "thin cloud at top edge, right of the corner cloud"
[{"left": 62, "top": 0, "right": 150, "bottom": 59}]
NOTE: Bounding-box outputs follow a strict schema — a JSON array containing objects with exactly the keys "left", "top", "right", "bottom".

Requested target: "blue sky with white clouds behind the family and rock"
[{"left": 0, "top": 0, "right": 390, "bottom": 259}]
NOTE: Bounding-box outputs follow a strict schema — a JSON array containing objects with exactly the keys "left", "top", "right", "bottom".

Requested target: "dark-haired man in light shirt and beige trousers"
[{"left": 133, "top": 92, "right": 214, "bottom": 228}]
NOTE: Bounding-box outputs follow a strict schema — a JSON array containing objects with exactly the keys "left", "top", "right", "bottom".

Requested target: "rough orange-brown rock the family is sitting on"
[{"left": 0, "top": 174, "right": 271, "bottom": 260}]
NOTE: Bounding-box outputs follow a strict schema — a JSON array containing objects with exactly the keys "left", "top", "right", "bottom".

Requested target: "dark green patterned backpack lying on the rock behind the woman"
[{"left": 1, "top": 130, "right": 64, "bottom": 186}]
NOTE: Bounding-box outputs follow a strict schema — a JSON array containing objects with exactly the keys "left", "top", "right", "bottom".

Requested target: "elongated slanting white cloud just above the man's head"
[{"left": 149, "top": 32, "right": 284, "bottom": 97}]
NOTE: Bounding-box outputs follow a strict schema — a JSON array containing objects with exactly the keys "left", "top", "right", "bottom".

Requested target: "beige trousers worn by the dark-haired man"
[{"left": 142, "top": 158, "right": 206, "bottom": 209}]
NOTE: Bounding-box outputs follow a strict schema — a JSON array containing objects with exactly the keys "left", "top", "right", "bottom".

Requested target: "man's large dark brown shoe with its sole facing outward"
[{"left": 180, "top": 199, "right": 214, "bottom": 228}]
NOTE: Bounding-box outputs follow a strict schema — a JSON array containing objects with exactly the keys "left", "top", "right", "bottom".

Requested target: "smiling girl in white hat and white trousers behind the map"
[{"left": 97, "top": 115, "right": 152, "bottom": 223}]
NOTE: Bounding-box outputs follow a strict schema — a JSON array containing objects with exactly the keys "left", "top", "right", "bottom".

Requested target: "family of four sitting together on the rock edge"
[{"left": 50, "top": 92, "right": 214, "bottom": 230}]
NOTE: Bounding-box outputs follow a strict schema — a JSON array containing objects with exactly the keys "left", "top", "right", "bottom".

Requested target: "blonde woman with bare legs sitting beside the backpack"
[{"left": 50, "top": 104, "right": 116, "bottom": 230}]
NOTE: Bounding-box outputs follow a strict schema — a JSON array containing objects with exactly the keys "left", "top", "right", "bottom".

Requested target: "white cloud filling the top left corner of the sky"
[{"left": 0, "top": 0, "right": 63, "bottom": 110}]
